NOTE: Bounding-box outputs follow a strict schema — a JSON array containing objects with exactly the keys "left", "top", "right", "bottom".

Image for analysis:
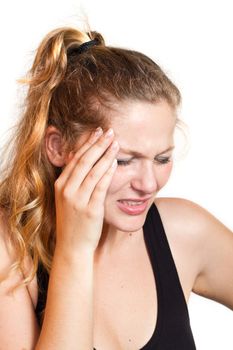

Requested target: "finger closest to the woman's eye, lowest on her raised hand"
[{"left": 78, "top": 141, "right": 119, "bottom": 207}]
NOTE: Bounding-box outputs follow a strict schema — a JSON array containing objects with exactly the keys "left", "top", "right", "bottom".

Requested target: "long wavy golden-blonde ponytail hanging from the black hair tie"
[{"left": 0, "top": 28, "right": 99, "bottom": 283}]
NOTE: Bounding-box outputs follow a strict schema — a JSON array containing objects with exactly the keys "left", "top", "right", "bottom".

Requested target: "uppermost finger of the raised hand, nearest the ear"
[{"left": 54, "top": 127, "right": 103, "bottom": 186}]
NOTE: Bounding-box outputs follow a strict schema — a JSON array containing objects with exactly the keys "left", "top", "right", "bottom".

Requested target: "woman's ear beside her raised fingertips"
[{"left": 45, "top": 126, "right": 67, "bottom": 167}]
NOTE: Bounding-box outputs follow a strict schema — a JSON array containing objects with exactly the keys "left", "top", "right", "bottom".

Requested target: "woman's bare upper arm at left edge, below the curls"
[{"left": 0, "top": 211, "right": 39, "bottom": 350}]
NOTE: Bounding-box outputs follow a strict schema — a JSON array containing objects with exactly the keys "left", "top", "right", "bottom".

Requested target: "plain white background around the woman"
[{"left": 0, "top": 0, "right": 233, "bottom": 350}]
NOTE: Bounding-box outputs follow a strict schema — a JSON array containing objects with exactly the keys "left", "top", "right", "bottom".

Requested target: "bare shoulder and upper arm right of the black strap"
[{"left": 155, "top": 197, "right": 233, "bottom": 309}]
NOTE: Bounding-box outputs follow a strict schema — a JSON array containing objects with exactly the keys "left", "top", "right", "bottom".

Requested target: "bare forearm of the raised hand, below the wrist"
[{"left": 35, "top": 251, "right": 94, "bottom": 350}]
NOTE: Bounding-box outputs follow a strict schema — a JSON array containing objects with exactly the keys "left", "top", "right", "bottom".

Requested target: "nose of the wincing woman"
[{"left": 131, "top": 162, "right": 158, "bottom": 194}]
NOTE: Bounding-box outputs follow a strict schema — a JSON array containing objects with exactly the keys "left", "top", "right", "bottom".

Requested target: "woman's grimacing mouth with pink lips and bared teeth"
[{"left": 117, "top": 198, "right": 149, "bottom": 215}]
